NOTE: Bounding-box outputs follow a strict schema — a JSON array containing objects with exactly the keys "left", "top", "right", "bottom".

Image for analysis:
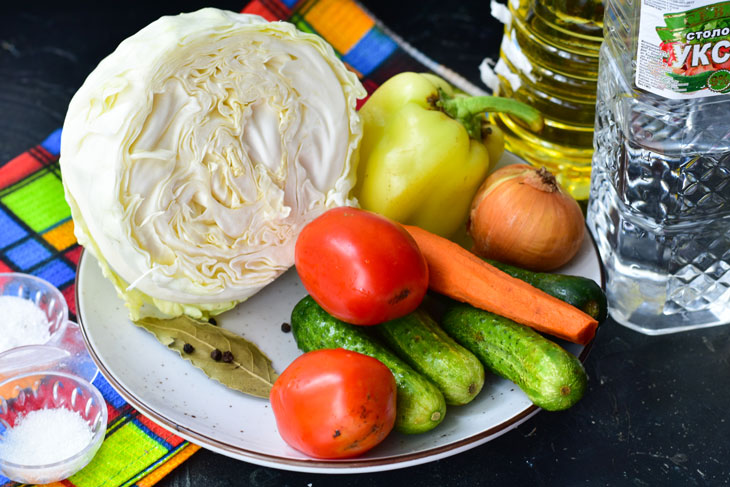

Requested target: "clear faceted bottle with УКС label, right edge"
[{"left": 587, "top": 0, "right": 730, "bottom": 334}]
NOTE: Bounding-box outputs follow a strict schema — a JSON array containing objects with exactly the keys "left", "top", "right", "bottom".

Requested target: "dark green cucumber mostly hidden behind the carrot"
[{"left": 487, "top": 260, "right": 608, "bottom": 323}]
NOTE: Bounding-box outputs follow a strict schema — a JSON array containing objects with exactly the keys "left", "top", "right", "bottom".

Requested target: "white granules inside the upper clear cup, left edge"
[{"left": 0, "top": 296, "right": 51, "bottom": 353}]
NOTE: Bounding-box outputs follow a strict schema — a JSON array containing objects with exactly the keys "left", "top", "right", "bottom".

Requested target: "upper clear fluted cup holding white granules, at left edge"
[{"left": 0, "top": 272, "right": 68, "bottom": 353}]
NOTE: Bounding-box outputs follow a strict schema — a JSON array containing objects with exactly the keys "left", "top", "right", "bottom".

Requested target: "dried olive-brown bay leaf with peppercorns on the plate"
[{"left": 134, "top": 316, "right": 278, "bottom": 399}]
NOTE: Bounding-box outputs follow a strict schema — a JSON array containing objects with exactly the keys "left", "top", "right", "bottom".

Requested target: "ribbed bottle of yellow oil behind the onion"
[{"left": 480, "top": 0, "right": 603, "bottom": 200}]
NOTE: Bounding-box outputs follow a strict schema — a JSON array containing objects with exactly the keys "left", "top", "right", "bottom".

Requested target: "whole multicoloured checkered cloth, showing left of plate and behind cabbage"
[{"left": 0, "top": 0, "right": 474, "bottom": 487}]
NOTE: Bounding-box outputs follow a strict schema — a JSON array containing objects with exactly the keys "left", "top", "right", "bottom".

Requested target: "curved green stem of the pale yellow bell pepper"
[{"left": 435, "top": 88, "right": 543, "bottom": 140}]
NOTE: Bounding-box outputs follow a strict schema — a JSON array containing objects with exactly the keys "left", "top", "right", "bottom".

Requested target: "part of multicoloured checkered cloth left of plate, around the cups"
[{"left": 0, "top": 130, "right": 199, "bottom": 487}]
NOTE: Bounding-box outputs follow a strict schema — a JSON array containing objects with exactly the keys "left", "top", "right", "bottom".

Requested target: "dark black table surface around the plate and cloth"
[{"left": 0, "top": 0, "right": 730, "bottom": 487}]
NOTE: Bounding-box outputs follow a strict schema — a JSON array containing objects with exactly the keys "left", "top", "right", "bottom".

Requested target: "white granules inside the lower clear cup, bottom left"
[{"left": 0, "top": 408, "right": 93, "bottom": 465}]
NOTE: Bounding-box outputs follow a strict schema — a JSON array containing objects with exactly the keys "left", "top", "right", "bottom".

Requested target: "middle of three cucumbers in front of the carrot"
[{"left": 373, "top": 309, "right": 484, "bottom": 405}]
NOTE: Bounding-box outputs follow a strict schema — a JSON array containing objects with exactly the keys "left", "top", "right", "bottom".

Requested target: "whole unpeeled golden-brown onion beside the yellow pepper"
[{"left": 468, "top": 164, "right": 585, "bottom": 271}]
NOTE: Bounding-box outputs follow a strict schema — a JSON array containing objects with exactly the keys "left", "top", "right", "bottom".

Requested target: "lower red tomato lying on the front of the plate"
[{"left": 269, "top": 348, "right": 396, "bottom": 458}]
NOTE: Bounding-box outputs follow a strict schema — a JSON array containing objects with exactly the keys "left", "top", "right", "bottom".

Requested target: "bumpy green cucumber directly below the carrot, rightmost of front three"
[{"left": 442, "top": 304, "right": 588, "bottom": 411}]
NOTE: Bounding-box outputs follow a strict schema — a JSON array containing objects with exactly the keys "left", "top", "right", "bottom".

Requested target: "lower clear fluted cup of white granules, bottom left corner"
[{"left": 0, "top": 371, "right": 107, "bottom": 484}]
